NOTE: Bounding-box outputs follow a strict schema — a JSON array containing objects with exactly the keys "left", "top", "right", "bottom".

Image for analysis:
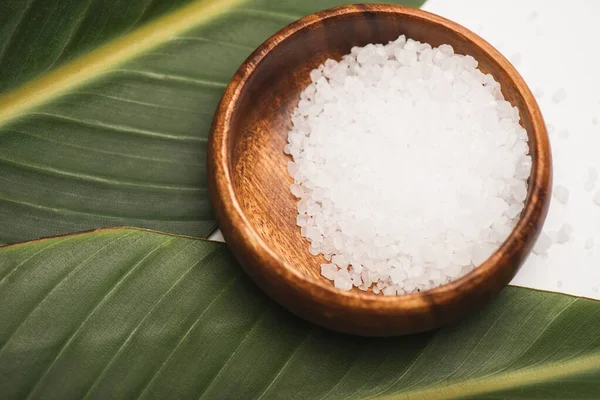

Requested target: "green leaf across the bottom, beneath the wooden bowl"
[{"left": 0, "top": 229, "right": 600, "bottom": 400}]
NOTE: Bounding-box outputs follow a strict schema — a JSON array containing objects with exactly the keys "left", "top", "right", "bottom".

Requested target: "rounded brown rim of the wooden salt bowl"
[{"left": 208, "top": 4, "right": 552, "bottom": 313}]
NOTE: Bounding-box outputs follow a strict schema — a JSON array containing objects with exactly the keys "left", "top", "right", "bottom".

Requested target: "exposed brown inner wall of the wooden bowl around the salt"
[{"left": 228, "top": 8, "right": 537, "bottom": 290}]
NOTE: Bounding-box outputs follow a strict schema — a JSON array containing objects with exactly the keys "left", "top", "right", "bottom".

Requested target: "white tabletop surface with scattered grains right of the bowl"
[{"left": 211, "top": 0, "right": 600, "bottom": 299}]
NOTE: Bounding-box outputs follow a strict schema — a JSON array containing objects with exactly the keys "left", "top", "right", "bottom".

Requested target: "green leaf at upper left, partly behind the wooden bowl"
[{"left": 0, "top": 0, "right": 422, "bottom": 244}]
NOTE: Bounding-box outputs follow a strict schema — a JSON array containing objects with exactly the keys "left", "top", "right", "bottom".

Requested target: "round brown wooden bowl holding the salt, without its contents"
[{"left": 208, "top": 5, "right": 551, "bottom": 336}]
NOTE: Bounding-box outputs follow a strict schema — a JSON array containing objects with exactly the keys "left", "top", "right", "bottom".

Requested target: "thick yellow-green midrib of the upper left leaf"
[{"left": 0, "top": 0, "right": 246, "bottom": 126}]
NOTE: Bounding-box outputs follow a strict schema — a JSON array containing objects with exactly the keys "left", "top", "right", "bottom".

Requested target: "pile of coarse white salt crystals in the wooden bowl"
[{"left": 285, "top": 36, "right": 531, "bottom": 295}]
